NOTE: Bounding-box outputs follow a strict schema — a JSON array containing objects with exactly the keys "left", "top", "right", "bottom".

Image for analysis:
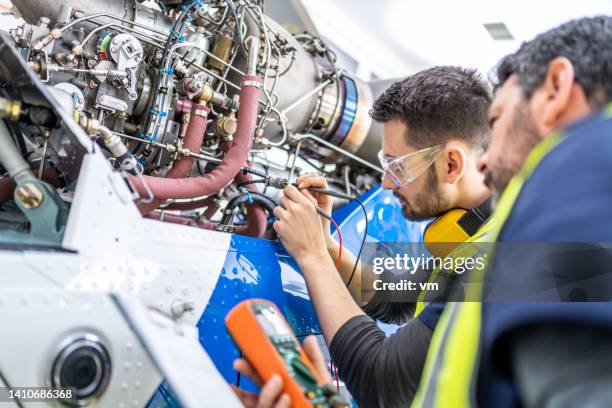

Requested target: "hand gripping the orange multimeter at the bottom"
[{"left": 232, "top": 336, "right": 332, "bottom": 408}]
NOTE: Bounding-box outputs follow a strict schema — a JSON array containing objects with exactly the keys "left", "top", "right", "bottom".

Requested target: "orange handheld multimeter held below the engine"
[{"left": 225, "top": 299, "right": 349, "bottom": 408}]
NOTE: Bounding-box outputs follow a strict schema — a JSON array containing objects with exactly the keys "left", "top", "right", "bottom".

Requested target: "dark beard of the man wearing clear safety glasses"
[{"left": 393, "top": 168, "right": 449, "bottom": 221}]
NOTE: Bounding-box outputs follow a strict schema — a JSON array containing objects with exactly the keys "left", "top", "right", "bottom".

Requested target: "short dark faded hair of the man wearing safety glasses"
[{"left": 370, "top": 66, "right": 491, "bottom": 148}]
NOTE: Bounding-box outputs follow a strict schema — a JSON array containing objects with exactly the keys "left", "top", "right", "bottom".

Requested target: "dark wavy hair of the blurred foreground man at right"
[{"left": 492, "top": 16, "right": 612, "bottom": 107}]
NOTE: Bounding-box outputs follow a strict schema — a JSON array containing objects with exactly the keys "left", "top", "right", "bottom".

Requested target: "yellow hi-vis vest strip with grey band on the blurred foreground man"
[{"left": 412, "top": 132, "right": 566, "bottom": 408}]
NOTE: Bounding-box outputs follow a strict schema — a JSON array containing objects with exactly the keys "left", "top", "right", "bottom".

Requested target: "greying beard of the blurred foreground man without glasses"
[{"left": 484, "top": 100, "right": 541, "bottom": 204}]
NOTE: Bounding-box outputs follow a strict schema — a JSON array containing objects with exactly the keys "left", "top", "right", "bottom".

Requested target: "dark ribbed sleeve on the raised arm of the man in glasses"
[{"left": 330, "top": 315, "right": 432, "bottom": 408}]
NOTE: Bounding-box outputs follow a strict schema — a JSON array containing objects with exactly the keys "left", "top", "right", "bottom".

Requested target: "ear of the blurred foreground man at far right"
[{"left": 532, "top": 57, "right": 574, "bottom": 134}]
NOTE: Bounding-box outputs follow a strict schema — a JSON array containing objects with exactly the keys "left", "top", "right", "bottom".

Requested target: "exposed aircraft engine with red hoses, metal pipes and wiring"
[{"left": 0, "top": 0, "right": 388, "bottom": 242}]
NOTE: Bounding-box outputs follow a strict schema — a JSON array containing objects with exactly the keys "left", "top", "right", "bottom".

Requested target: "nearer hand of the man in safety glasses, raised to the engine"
[{"left": 274, "top": 186, "right": 329, "bottom": 266}]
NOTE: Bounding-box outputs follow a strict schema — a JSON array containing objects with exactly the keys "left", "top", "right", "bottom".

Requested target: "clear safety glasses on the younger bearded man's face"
[{"left": 378, "top": 144, "right": 444, "bottom": 187}]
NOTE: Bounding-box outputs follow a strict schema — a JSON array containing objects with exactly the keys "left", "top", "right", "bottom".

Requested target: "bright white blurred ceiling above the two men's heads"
[{"left": 303, "top": 0, "right": 612, "bottom": 77}]
